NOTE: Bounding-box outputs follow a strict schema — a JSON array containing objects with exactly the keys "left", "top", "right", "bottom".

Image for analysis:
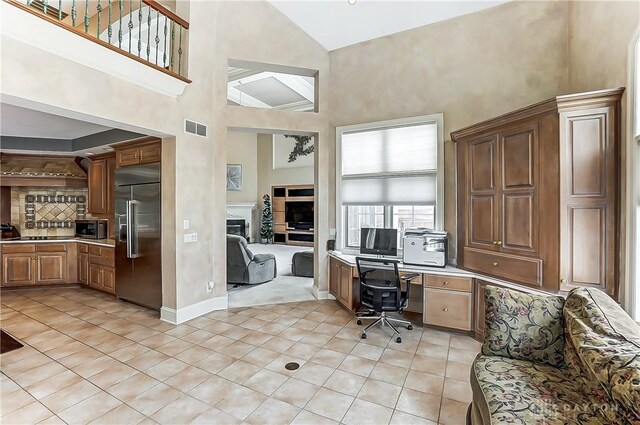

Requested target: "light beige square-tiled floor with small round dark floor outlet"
[{"left": 0, "top": 288, "right": 480, "bottom": 425}]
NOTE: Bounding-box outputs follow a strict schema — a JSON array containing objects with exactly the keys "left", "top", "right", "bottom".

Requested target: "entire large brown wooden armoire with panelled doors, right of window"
[{"left": 451, "top": 88, "right": 624, "bottom": 298}]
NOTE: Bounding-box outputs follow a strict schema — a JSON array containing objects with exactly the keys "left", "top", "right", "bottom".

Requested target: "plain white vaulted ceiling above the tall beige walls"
[{"left": 268, "top": 0, "right": 508, "bottom": 50}]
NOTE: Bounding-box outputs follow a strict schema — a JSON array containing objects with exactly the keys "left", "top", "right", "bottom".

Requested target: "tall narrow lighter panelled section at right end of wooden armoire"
[{"left": 560, "top": 99, "right": 620, "bottom": 296}]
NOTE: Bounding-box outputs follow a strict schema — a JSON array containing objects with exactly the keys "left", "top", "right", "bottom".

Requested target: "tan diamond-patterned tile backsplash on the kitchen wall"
[{"left": 11, "top": 187, "right": 90, "bottom": 236}]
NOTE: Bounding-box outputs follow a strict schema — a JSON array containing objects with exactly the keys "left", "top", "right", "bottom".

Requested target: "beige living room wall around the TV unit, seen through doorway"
[{"left": 258, "top": 134, "right": 313, "bottom": 207}]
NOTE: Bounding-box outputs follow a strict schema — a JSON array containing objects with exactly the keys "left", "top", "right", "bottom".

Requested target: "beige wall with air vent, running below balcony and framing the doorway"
[{"left": 0, "top": 1, "right": 329, "bottom": 309}]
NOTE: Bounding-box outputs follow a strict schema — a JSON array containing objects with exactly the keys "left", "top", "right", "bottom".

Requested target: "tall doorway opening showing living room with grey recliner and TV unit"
[{"left": 226, "top": 129, "right": 317, "bottom": 308}]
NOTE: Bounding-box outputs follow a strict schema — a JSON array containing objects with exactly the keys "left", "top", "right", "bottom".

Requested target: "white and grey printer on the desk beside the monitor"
[{"left": 402, "top": 227, "right": 448, "bottom": 267}]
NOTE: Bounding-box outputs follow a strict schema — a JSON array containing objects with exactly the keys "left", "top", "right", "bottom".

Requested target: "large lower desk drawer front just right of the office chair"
[{"left": 423, "top": 288, "right": 472, "bottom": 331}]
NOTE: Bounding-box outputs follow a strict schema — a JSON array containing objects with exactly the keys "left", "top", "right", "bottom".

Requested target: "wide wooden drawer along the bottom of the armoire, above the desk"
[{"left": 464, "top": 248, "right": 542, "bottom": 286}]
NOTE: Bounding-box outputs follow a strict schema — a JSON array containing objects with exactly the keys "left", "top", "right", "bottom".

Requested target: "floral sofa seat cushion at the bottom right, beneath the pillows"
[{"left": 471, "top": 354, "right": 635, "bottom": 425}]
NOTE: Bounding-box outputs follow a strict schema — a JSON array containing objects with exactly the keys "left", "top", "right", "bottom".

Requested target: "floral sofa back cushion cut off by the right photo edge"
[{"left": 564, "top": 288, "right": 640, "bottom": 423}]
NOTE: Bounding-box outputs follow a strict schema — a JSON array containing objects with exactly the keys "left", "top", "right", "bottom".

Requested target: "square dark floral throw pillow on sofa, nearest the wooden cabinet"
[{"left": 482, "top": 285, "right": 564, "bottom": 366}]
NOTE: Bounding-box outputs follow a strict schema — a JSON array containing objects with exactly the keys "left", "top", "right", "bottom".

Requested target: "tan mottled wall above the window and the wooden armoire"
[{"left": 330, "top": 2, "right": 568, "bottom": 257}]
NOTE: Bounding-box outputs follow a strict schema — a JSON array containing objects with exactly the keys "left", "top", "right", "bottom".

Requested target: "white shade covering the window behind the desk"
[{"left": 342, "top": 123, "right": 438, "bottom": 205}]
